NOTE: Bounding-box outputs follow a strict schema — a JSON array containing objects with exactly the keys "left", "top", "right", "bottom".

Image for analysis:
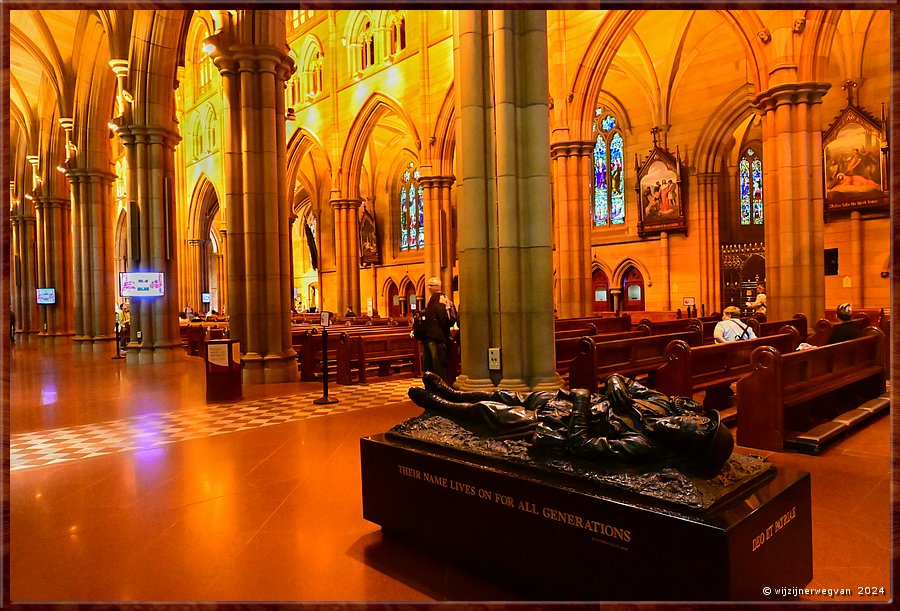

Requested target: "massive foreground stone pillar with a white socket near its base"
[{"left": 454, "top": 10, "right": 561, "bottom": 390}]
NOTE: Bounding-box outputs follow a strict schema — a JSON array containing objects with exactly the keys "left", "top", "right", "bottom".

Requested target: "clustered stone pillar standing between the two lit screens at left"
[{"left": 66, "top": 168, "right": 116, "bottom": 352}]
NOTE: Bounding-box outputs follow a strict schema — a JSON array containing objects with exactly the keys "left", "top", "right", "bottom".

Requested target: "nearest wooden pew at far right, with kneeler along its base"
[{"left": 737, "top": 327, "right": 885, "bottom": 454}]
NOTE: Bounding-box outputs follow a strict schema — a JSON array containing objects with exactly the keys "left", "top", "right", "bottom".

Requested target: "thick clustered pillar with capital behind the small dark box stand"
[{"left": 207, "top": 10, "right": 297, "bottom": 383}]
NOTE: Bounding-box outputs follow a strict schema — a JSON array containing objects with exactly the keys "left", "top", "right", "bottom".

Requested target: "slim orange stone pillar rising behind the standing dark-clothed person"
[{"left": 419, "top": 176, "right": 454, "bottom": 298}]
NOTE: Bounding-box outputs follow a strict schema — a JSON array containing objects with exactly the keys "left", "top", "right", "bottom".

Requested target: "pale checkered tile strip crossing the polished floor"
[{"left": 9, "top": 378, "right": 422, "bottom": 471}]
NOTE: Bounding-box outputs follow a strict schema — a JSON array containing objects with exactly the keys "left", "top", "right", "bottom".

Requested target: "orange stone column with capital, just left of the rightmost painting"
[{"left": 754, "top": 83, "right": 830, "bottom": 320}]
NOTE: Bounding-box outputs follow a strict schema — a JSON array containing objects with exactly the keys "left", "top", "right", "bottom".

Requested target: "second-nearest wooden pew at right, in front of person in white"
[{"left": 656, "top": 326, "right": 800, "bottom": 409}]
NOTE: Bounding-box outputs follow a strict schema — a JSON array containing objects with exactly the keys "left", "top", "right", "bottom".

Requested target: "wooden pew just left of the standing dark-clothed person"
[{"left": 338, "top": 330, "right": 422, "bottom": 384}]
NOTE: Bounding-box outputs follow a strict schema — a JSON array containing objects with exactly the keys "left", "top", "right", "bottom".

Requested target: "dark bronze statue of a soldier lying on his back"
[{"left": 409, "top": 372, "right": 734, "bottom": 476}]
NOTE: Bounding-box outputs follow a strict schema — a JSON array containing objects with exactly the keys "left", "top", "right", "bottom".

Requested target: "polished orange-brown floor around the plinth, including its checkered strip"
[{"left": 9, "top": 339, "right": 893, "bottom": 603}]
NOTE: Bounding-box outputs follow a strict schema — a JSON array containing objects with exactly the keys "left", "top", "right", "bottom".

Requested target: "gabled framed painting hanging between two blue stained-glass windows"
[{"left": 635, "top": 140, "right": 687, "bottom": 237}]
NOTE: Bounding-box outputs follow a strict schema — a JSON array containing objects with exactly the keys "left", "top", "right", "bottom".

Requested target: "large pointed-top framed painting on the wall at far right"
[{"left": 822, "top": 104, "right": 888, "bottom": 217}]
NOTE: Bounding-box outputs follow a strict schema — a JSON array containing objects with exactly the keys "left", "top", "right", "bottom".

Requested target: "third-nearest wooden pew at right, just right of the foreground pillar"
[{"left": 569, "top": 327, "right": 703, "bottom": 393}]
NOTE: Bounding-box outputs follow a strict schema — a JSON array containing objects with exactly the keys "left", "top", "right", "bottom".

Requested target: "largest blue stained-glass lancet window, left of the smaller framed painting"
[{"left": 593, "top": 108, "right": 625, "bottom": 227}]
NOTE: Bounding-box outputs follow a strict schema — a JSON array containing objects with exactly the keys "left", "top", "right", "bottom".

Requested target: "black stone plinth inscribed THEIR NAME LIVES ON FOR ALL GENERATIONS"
[{"left": 360, "top": 435, "right": 812, "bottom": 601}]
